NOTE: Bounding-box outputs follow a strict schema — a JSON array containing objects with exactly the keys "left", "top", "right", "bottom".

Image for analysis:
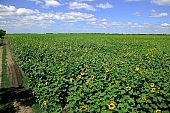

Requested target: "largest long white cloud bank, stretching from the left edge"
[{"left": 0, "top": 4, "right": 97, "bottom": 29}]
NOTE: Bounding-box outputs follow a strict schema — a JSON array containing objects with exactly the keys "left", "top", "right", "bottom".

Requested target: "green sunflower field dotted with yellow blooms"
[{"left": 8, "top": 34, "right": 170, "bottom": 113}]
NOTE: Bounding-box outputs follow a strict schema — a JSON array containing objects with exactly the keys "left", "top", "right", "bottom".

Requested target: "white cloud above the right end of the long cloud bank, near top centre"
[{"left": 69, "top": 2, "right": 96, "bottom": 11}]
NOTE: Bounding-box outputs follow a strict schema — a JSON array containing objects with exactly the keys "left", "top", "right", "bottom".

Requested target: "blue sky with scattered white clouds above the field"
[{"left": 0, "top": 0, "right": 170, "bottom": 34}]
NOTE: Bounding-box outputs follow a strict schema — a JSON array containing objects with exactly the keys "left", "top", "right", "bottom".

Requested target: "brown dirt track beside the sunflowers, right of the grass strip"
[{"left": 5, "top": 38, "right": 33, "bottom": 113}]
